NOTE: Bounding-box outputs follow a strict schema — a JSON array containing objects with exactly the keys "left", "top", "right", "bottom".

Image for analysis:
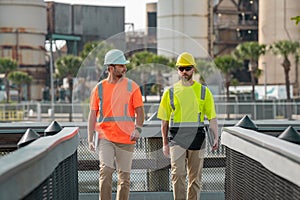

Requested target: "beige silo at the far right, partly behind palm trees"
[{"left": 259, "top": 0, "right": 300, "bottom": 94}]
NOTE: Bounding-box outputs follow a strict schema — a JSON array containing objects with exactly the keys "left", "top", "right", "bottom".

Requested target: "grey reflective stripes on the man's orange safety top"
[{"left": 97, "top": 79, "right": 135, "bottom": 122}]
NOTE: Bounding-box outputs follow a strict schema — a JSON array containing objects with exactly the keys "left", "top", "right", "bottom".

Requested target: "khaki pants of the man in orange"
[{"left": 99, "top": 139, "right": 134, "bottom": 200}]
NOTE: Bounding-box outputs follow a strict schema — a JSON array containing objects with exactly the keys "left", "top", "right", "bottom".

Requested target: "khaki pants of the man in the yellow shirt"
[{"left": 170, "top": 145, "right": 205, "bottom": 200}]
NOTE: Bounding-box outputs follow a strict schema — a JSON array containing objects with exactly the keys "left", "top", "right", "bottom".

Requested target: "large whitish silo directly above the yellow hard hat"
[{"left": 157, "top": 0, "right": 209, "bottom": 58}]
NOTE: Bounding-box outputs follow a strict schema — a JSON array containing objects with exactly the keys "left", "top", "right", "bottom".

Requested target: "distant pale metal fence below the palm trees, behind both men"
[{"left": 0, "top": 100, "right": 300, "bottom": 122}]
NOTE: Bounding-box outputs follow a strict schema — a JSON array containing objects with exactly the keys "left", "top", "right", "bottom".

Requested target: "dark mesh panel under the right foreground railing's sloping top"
[{"left": 225, "top": 147, "right": 300, "bottom": 200}]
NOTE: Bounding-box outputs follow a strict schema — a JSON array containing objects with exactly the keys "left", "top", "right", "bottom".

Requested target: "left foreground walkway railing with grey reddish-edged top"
[{"left": 0, "top": 127, "right": 79, "bottom": 199}]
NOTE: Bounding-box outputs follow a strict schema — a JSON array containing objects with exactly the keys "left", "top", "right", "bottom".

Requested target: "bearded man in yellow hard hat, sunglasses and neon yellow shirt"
[{"left": 157, "top": 52, "right": 218, "bottom": 200}]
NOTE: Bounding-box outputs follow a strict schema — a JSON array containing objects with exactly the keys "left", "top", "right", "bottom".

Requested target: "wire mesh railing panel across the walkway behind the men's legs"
[{"left": 78, "top": 137, "right": 225, "bottom": 193}]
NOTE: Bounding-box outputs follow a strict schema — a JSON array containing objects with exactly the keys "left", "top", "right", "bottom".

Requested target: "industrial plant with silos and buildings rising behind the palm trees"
[{"left": 0, "top": 0, "right": 300, "bottom": 100}]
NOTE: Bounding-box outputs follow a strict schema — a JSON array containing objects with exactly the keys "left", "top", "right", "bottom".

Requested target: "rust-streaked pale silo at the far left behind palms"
[{"left": 0, "top": 0, "right": 47, "bottom": 100}]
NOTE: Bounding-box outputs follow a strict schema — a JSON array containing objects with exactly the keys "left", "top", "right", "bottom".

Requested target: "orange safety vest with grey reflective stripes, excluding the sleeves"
[{"left": 97, "top": 78, "right": 138, "bottom": 144}]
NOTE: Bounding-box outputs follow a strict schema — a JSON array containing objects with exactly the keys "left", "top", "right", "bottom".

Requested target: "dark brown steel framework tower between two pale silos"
[{"left": 212, "top": 0, "right": 258, "bottom": 57}]
